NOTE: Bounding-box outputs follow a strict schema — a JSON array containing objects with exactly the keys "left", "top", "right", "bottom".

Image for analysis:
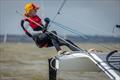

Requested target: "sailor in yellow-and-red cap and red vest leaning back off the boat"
[{"left": 21, "top": 3, "right": 79, "bottom": 54}]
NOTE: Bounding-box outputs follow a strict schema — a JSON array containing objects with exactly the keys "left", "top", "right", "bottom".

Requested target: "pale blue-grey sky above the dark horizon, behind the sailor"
[{"left": 0, "top": 0, "right": 120, "bottom": 36}]
